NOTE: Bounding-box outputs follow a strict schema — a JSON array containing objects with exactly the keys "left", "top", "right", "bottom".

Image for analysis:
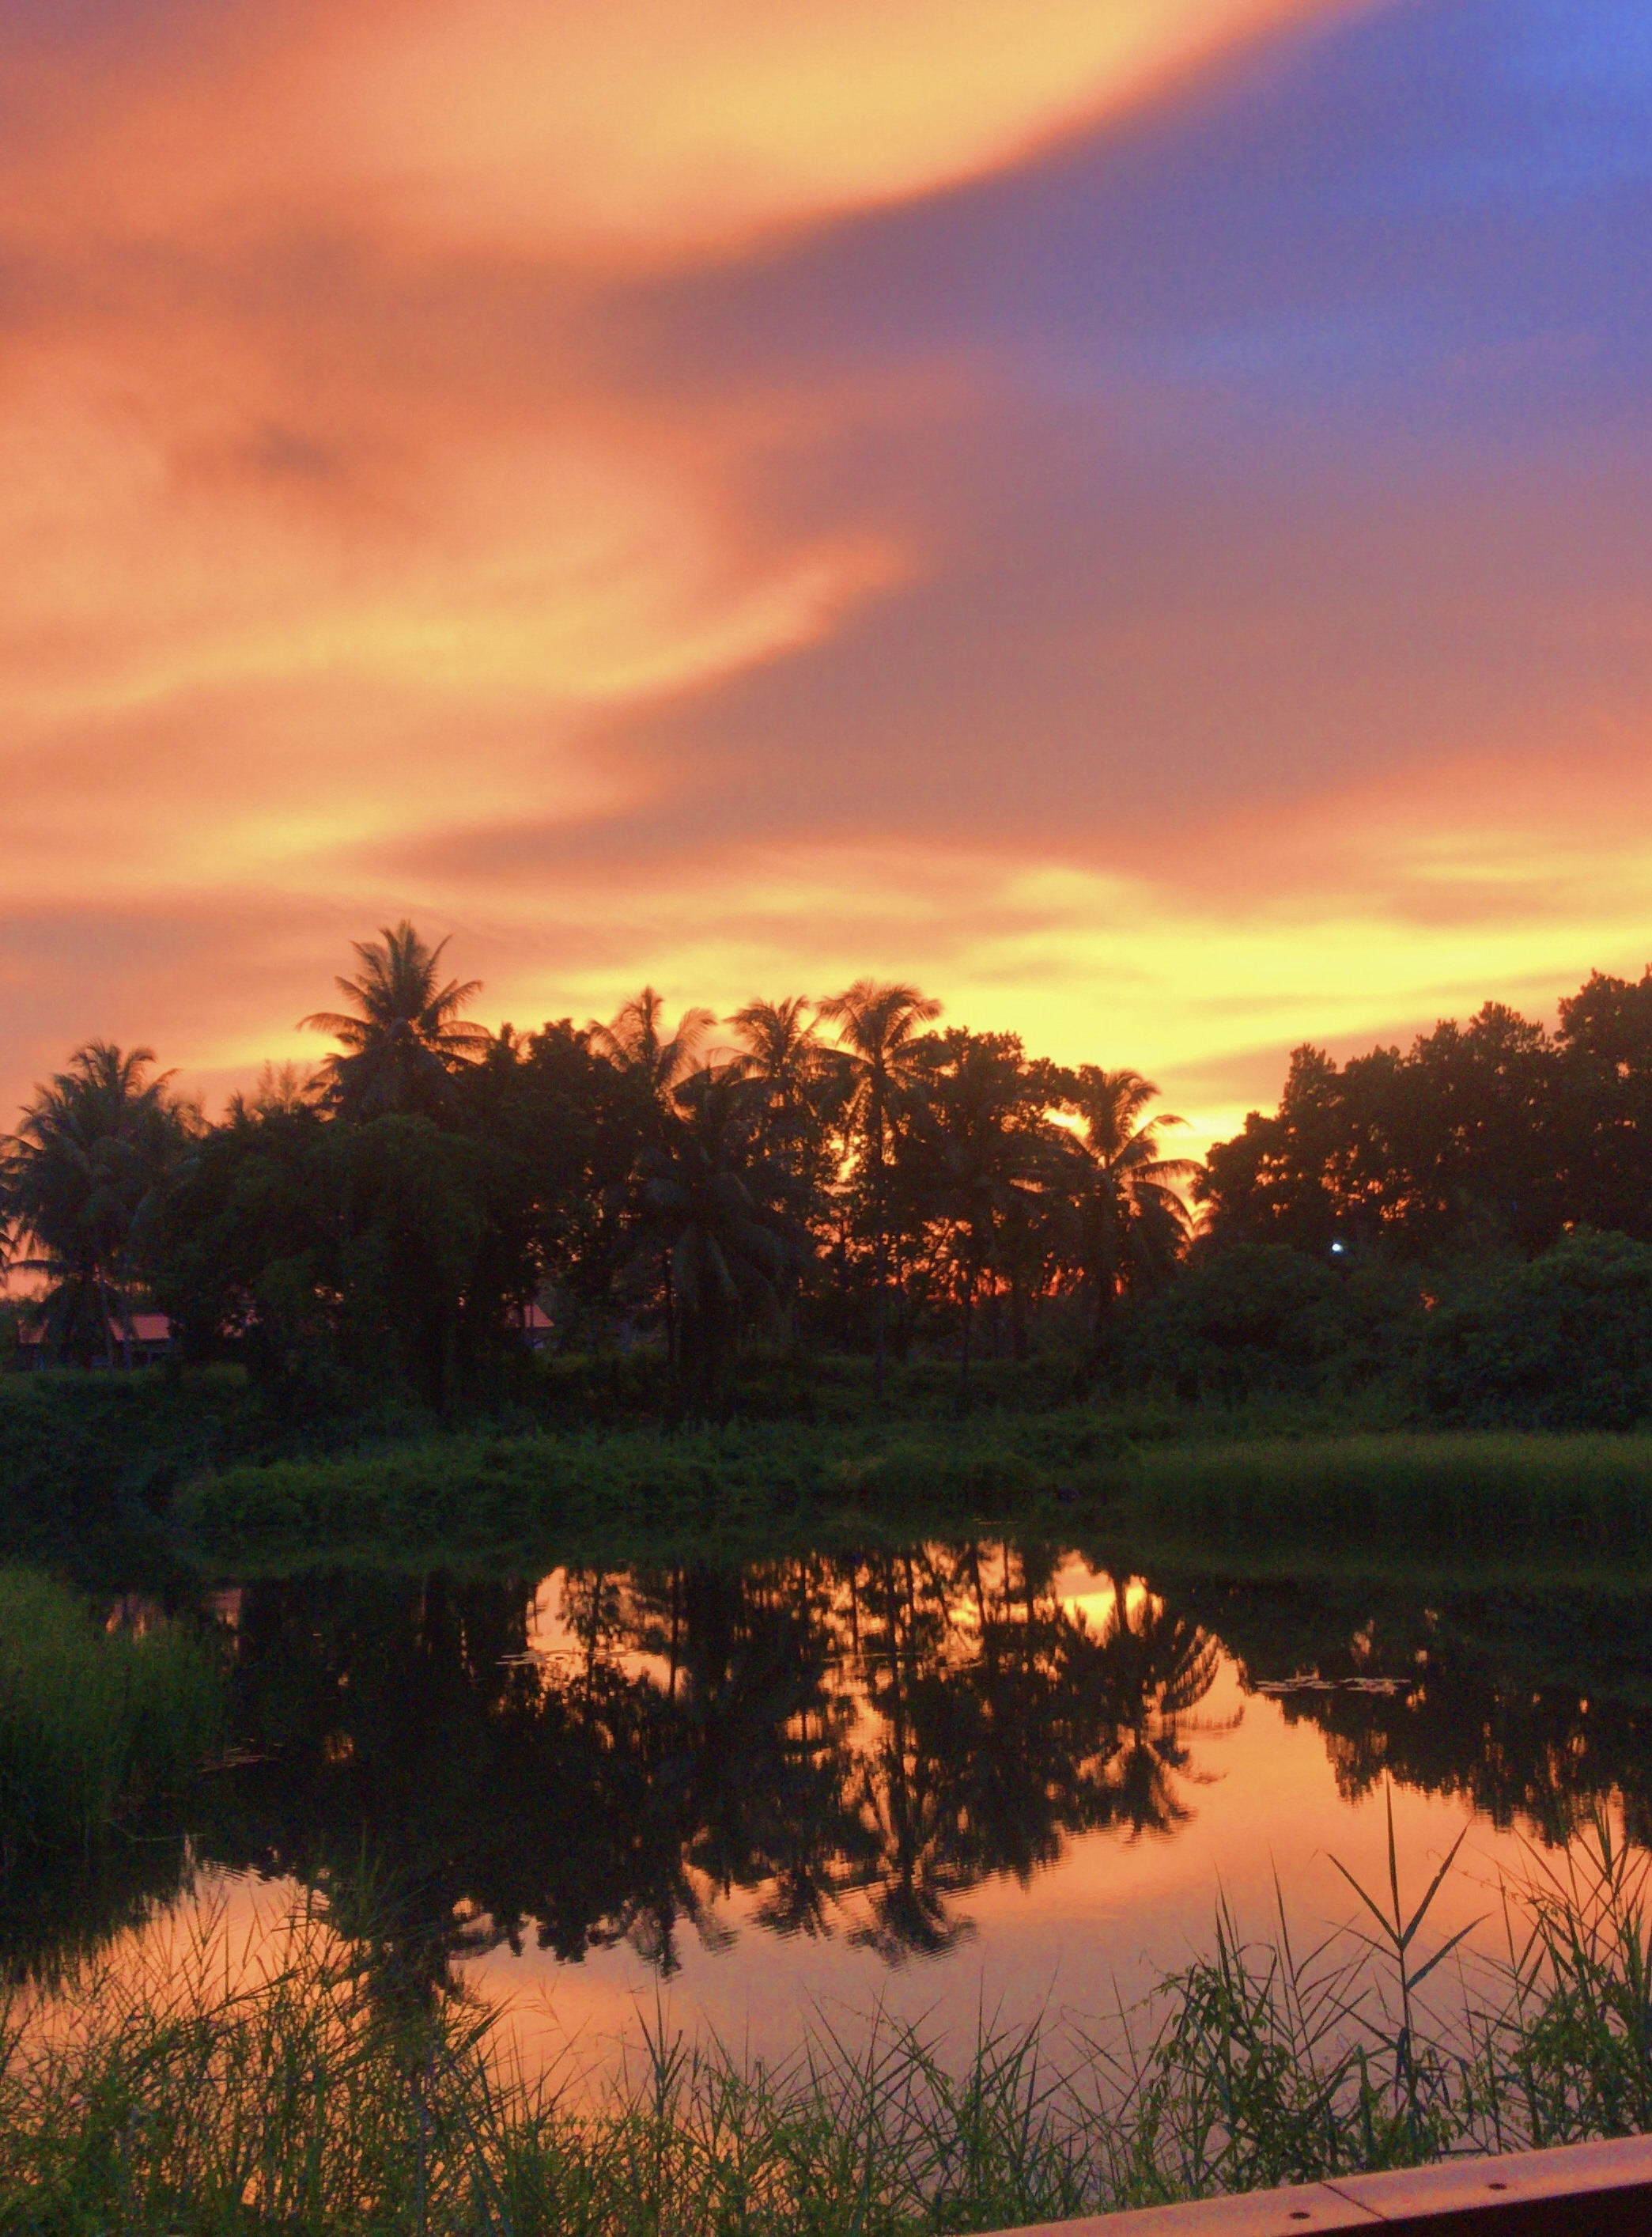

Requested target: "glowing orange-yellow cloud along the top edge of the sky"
[{"left": 11, "top": 0, "right": 1370, "bottom": 264}]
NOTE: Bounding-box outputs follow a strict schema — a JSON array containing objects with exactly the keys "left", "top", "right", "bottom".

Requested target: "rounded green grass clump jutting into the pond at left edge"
[{"left": 0, "top": 1570, "right": 221, "bottom": 1877}]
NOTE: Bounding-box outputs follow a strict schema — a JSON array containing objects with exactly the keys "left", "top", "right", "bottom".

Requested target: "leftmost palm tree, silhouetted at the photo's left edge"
[{"left": 0, "top": 1040, "right": 192, "bottom": 1367}]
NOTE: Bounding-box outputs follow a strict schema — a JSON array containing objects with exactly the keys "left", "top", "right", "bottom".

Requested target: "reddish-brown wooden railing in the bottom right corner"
[{"left": 983, "top": 2137, "right": 1652, "bottom": 2237}]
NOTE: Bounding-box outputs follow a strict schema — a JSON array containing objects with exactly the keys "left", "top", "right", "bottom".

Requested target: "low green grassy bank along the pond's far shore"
[{"left": 179, "top": 1407, "right": 1652, "bottom": 1580}]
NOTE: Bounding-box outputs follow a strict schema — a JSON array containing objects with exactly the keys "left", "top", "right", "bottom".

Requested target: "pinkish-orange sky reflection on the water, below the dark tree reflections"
[{"left": 470, "top": 1559, "right": 1522, "bottom": 2065}]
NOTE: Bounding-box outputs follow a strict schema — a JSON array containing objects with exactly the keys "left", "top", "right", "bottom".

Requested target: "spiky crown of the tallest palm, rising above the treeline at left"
[{"left": 300, "top": 919, "right": 490, "bottom": 1118}]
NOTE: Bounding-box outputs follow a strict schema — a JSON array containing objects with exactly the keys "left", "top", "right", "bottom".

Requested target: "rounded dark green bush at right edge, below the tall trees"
[{"left": 1422, "top": 1235, "right": 1652, "bottom": 1429}]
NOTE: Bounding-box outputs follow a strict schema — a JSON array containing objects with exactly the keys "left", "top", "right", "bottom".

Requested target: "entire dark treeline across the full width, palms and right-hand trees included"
[{"left": 0, "top": 924, "right": 1652, "bottom": 1427}]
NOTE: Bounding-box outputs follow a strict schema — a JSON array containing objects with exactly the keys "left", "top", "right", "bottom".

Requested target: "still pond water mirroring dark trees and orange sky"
[{"left": 25, "top": 1541, "right": 1652, "bottom": 2065}]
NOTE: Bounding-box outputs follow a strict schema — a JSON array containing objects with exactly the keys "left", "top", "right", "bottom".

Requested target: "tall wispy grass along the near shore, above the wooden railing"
[{"left": 0, "top": 1821, "right": 1652, "bottom": 2237}]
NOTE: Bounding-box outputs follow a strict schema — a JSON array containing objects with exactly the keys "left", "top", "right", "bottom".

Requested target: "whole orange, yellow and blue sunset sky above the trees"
[{"left": 0, "top": 0, "right": 1652, "bottom": 1143}]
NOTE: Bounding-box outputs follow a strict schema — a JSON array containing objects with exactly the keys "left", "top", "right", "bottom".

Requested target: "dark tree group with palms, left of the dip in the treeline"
[{"left": 0, "top": 924, "right": 1196, "bottom": 1410}]
